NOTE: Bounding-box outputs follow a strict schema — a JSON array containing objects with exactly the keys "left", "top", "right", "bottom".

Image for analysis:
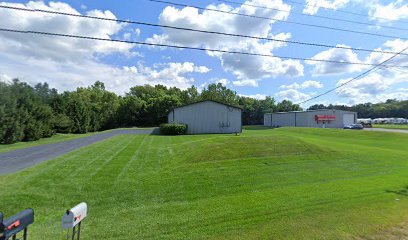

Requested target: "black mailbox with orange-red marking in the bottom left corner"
[{"left": 3, "top": 208, "right": 34, "bottom": 239}]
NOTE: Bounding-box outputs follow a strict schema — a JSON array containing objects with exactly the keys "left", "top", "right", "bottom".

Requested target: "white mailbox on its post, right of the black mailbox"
[{"left": 62, "top": 202, "right": 88, "bottom": 240}]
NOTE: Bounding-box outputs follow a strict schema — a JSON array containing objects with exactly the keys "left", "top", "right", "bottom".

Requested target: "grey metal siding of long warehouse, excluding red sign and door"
[{"left": 264, "top": 110, "right": 357, "bottom": 128}]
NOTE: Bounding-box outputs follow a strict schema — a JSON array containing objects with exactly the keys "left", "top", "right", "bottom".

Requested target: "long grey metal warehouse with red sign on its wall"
[{"left": 264, "top": 109, "right": 357, "bottom": 128}]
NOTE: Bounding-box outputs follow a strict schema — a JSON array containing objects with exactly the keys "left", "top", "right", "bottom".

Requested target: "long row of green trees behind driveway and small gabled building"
[{"left": 0, "top": 79, "right": 301, "bottom": 144}]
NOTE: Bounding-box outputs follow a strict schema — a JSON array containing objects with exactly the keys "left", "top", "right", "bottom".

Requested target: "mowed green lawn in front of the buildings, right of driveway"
[{"left": 0, "top": 128, "right": 408, "bottom": 240}]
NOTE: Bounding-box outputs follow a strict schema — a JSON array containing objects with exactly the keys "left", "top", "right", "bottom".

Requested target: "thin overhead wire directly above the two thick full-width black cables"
[{"left": 148, "top": 0, "right": 408, "bottom": 40}]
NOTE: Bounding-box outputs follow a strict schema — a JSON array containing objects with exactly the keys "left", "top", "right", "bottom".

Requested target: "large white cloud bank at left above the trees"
[{"left": 0, "top": 1, "right": 210, "bottom": 94}]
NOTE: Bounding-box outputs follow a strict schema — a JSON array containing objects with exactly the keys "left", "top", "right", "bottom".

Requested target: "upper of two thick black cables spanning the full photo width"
[{"left": 0, "top": 5, "right": 408, "bottom": 55}]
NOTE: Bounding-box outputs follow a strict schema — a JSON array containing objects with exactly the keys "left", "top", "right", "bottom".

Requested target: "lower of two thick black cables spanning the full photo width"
[{"left": 0, "top": 28, "right": 408, "bottom": 68}]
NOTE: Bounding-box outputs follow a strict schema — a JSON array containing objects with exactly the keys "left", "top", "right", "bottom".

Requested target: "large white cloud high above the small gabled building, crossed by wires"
[{"left": 146, "top": 0, "right": 303, "bottom": 86}]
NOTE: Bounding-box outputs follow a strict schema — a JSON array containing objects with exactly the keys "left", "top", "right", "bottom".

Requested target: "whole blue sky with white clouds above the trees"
[{"left": 0, "top": 0, "right": 408, "bottom": 107}]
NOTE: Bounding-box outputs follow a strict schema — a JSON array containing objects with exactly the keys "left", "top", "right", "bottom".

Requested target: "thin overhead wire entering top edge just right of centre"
[{"left": 218, "top": 0, "right": 408, "bottom": 31}]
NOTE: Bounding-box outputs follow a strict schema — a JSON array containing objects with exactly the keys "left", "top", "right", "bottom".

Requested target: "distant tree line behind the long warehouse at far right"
[{"left": 309, "top": 99, "right": 408, "bottom": 118}]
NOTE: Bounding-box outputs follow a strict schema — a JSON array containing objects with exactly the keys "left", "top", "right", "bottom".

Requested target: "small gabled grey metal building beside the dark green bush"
[{"left": 168, "top": 100, "right": 242, "bottom": 134}]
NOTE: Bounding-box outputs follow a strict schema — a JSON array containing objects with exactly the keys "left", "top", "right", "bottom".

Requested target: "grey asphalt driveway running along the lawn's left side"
[{"left": 0, "top": 129, "right": 154, "bottom": 175}]
